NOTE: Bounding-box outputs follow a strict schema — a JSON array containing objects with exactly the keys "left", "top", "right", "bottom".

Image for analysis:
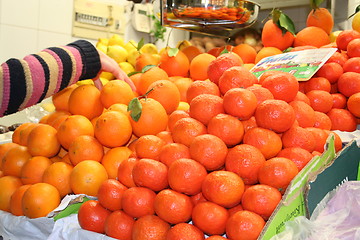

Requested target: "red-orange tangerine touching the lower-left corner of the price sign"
[{"left": 218, "top": 66, "right": 258, "bottom": 94}]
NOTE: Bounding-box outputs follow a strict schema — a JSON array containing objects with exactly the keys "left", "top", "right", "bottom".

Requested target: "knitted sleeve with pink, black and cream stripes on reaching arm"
[{"left": 0, "top": 40, "right": 101, "bottom": 117}]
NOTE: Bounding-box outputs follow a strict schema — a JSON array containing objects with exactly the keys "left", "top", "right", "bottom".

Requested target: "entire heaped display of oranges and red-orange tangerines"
[{"left": 0, "top": 7, "right": 360, "bottom": 240}]
